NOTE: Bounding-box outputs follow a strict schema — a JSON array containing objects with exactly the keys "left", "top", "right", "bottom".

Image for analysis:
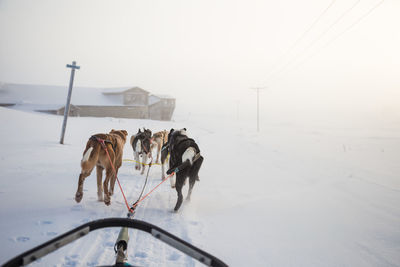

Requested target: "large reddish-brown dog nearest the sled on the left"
[{"left": 75, "top": 129, "right": 128, "bottom": 205}]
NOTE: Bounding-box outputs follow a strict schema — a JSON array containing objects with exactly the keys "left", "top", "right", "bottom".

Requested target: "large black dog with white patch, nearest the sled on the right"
[{"left": 161, "top": 128, "right": 204, "bottom": 211}]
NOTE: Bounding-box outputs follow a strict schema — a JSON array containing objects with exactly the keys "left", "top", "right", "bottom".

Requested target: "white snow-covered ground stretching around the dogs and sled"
[{"left": 0, "top": 108, "right": 400, "bottom": 266}]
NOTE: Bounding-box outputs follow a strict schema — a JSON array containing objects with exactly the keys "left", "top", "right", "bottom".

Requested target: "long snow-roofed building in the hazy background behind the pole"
[{"left": 0, "top": 84, "right": 175, "bottom": 121}]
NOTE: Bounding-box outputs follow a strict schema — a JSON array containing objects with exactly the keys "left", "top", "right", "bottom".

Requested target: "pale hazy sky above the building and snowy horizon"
[{"left": 0, "top": 0, "right": 400, "bottom": 116}]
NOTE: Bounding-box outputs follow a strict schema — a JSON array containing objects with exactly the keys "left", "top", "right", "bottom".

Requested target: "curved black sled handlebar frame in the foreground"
[{"left": 3, "top": 218, "right": 228, "bottom": 267}]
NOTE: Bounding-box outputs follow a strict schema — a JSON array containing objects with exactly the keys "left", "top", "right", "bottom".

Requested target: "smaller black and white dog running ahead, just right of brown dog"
[{"left": 131, "top": 128, "right": 151, "bottom": 174}]
